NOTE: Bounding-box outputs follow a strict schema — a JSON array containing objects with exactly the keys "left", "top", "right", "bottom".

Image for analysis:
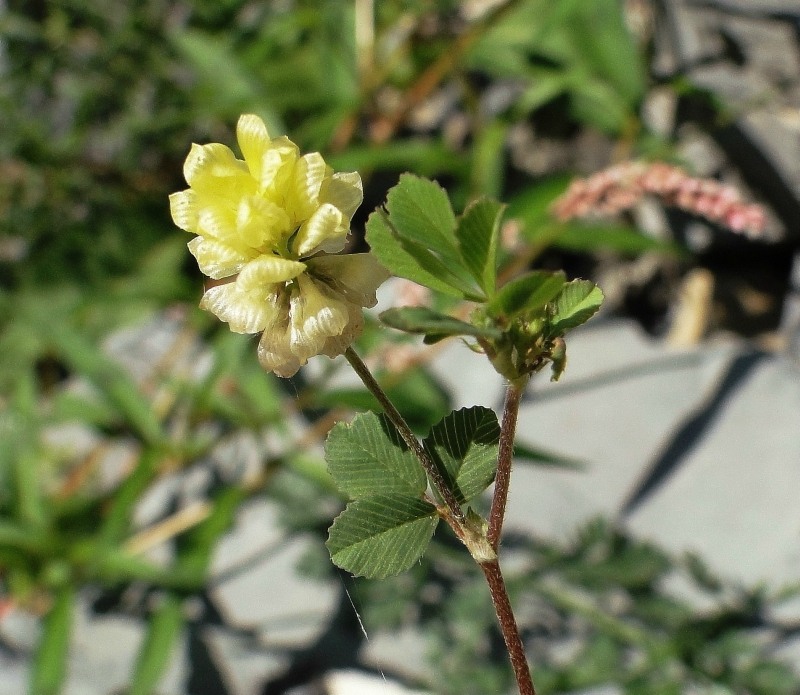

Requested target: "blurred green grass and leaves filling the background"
[{"left": 0, "top": 0, "right": 797, "bottom": 695}]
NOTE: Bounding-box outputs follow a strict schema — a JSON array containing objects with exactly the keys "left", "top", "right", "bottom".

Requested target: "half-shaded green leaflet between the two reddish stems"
[{"left": 423, "top": 406, "right": 500, "bottom": 504}]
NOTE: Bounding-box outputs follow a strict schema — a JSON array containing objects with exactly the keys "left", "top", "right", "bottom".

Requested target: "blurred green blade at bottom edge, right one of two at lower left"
[{"left": 128, "top": 594, "right": 184, "bottom": 695}]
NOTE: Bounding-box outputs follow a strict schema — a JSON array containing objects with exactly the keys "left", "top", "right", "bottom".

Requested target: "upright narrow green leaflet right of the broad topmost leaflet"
[{"left": 456, "top": 198, "right": 503, "bottom": 295}]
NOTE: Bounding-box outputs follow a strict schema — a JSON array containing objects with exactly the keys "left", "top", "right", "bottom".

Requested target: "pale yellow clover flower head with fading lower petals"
[{"left": 170, "top": 115, "right": 388, "bottom": 377}]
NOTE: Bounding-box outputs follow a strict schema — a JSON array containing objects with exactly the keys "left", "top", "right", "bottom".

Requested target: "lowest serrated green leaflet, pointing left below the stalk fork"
[{"left": 325, "top": 494, "right": 439, "bottom": 579}]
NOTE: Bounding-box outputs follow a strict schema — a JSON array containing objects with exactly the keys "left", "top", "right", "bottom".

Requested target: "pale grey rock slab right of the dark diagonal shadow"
[{"left": 628, "top": 357, "right": 800, "bottom": 586}]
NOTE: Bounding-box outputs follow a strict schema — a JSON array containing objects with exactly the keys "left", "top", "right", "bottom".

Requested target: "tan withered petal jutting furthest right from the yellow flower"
[{"left": 307, "top": 253, "right": 389, "bottom": 307}]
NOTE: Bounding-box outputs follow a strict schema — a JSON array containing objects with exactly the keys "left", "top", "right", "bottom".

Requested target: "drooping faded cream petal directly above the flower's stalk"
[{"left": 289, "top": 275, "right": 349, "bottom": 362}]
